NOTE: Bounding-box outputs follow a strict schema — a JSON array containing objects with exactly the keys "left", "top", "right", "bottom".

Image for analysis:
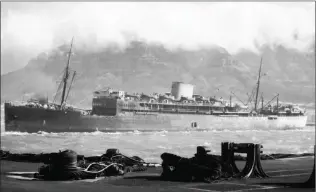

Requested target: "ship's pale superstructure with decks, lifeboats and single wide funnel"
[{"left": 92, "top": 82, "right": 304, "bottom": 116}]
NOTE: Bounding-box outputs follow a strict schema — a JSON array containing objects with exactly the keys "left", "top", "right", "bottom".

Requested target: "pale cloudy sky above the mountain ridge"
[{"left": 1, "top": 2, "right": 315, "bottom": 74}]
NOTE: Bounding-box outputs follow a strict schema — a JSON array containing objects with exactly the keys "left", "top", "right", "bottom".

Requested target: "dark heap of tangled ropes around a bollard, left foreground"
[{"left": 0, "top": 149, "right": 157, "bottom": 180}]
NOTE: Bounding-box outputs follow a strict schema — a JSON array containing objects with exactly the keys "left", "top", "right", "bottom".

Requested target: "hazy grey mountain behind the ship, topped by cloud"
[{"left": 1, "top": 41, "right": 315, "bottom": 106}]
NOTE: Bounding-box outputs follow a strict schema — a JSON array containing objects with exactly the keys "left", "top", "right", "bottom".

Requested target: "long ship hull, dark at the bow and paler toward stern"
[{"left": 4, "top": 105, "right": 307, "bottom": 132}]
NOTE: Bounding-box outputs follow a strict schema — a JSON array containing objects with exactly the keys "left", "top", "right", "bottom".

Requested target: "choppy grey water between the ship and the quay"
[{"left": 1, "top": 104, "right": 315, "bottom": 162}]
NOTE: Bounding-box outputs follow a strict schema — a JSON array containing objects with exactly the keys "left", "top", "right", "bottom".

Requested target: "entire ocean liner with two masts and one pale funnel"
[{"left": 4, "top": 42, "right": 307, "bottom": 132}]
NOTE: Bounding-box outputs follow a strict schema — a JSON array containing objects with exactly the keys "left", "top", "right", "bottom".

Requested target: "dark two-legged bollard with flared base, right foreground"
[{"left": 222, "top": 142, "right": 269, "bottom": 178}]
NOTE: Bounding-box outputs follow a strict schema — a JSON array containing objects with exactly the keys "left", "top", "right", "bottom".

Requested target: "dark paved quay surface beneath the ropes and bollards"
[{"left": 1, "top": 157, "right": 315, "bottom": 192}]
